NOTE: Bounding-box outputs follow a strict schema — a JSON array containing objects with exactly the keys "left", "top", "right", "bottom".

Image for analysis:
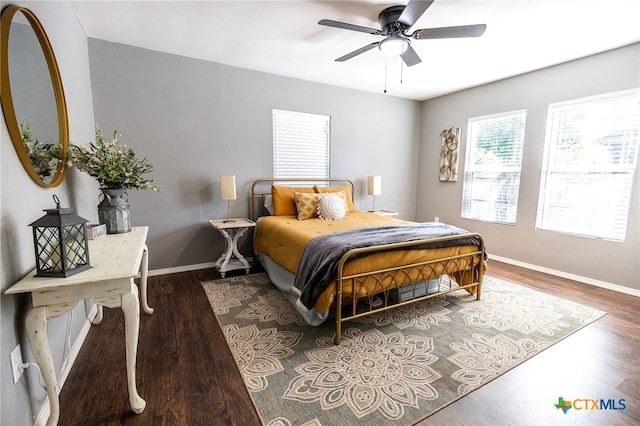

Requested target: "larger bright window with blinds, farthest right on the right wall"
[{"left": 536, "top": 90, "right": 640, "bottom": 241}]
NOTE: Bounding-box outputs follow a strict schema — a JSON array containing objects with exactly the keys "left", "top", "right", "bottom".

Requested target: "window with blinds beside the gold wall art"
[{"left": 462, "top": 111, "right": 526, "bottom": 224}]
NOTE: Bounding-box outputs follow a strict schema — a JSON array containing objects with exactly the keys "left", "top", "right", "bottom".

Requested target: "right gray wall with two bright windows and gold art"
[{"left": 416, "top": 44, "right": 640, "bottom": 290}]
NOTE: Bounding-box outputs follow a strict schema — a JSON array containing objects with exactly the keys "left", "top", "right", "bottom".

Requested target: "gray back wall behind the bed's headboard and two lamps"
[{"left": 89, "top": 39, "right": 421, "bottom": 269}]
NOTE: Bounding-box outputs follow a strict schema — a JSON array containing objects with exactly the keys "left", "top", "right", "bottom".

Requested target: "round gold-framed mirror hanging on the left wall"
[{"left": 0, "top": 5, "right": 69, "bottom": 187}]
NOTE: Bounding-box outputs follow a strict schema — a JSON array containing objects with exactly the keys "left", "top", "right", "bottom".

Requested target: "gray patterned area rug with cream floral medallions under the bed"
[{"left": 202, "top": 273, "right": 605, "bottom": 426}]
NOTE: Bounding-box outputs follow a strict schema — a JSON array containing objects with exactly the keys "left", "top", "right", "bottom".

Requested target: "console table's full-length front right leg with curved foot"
[{"left": 121, "top": 280, "right": 147, "bottom": 414}]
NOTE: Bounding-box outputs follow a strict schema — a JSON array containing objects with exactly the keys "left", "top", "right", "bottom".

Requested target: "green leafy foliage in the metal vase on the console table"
[{"left": 67, "top": 126, "right": 160, "bottom": 191}]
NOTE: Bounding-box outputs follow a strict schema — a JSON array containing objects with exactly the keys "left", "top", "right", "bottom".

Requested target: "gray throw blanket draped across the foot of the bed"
[{"left": 294, "top": 222, "right": 486, "bottom": 309}]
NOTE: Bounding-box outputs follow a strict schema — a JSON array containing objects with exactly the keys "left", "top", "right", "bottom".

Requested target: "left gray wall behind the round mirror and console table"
[{"left": 0, "top": 2, "right": 97, "bottom": 425}]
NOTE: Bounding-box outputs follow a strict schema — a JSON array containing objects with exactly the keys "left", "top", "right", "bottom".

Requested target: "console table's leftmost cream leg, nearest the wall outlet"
[{"left": 25, "top": 306, "right": 60, "bottom": 426}]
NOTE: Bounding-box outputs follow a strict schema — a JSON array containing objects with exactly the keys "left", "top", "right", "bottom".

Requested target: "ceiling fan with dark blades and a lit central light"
[{"left": 318, "top": 0, "right": 487, "bottom": 67}]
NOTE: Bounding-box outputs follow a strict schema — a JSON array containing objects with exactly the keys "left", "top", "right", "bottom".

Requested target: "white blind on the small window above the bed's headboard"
[{"left": 273, "top": 109, "right": 331, "bottom": 178}]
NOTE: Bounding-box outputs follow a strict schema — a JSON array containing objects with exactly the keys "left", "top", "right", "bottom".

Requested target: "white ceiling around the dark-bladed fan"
[{"left": 67, "top": 0, "right": 640, "bottom": 100}]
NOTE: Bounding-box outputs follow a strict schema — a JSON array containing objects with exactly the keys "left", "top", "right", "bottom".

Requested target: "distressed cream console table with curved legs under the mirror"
[{"left": 5, "top": 226, "right": 153, "bottom": 425}]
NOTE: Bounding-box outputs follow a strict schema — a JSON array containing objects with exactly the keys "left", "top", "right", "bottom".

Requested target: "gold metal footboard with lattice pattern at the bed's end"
[{"left": 334, "top": 233, "right": 486, "bottom": 345}]
